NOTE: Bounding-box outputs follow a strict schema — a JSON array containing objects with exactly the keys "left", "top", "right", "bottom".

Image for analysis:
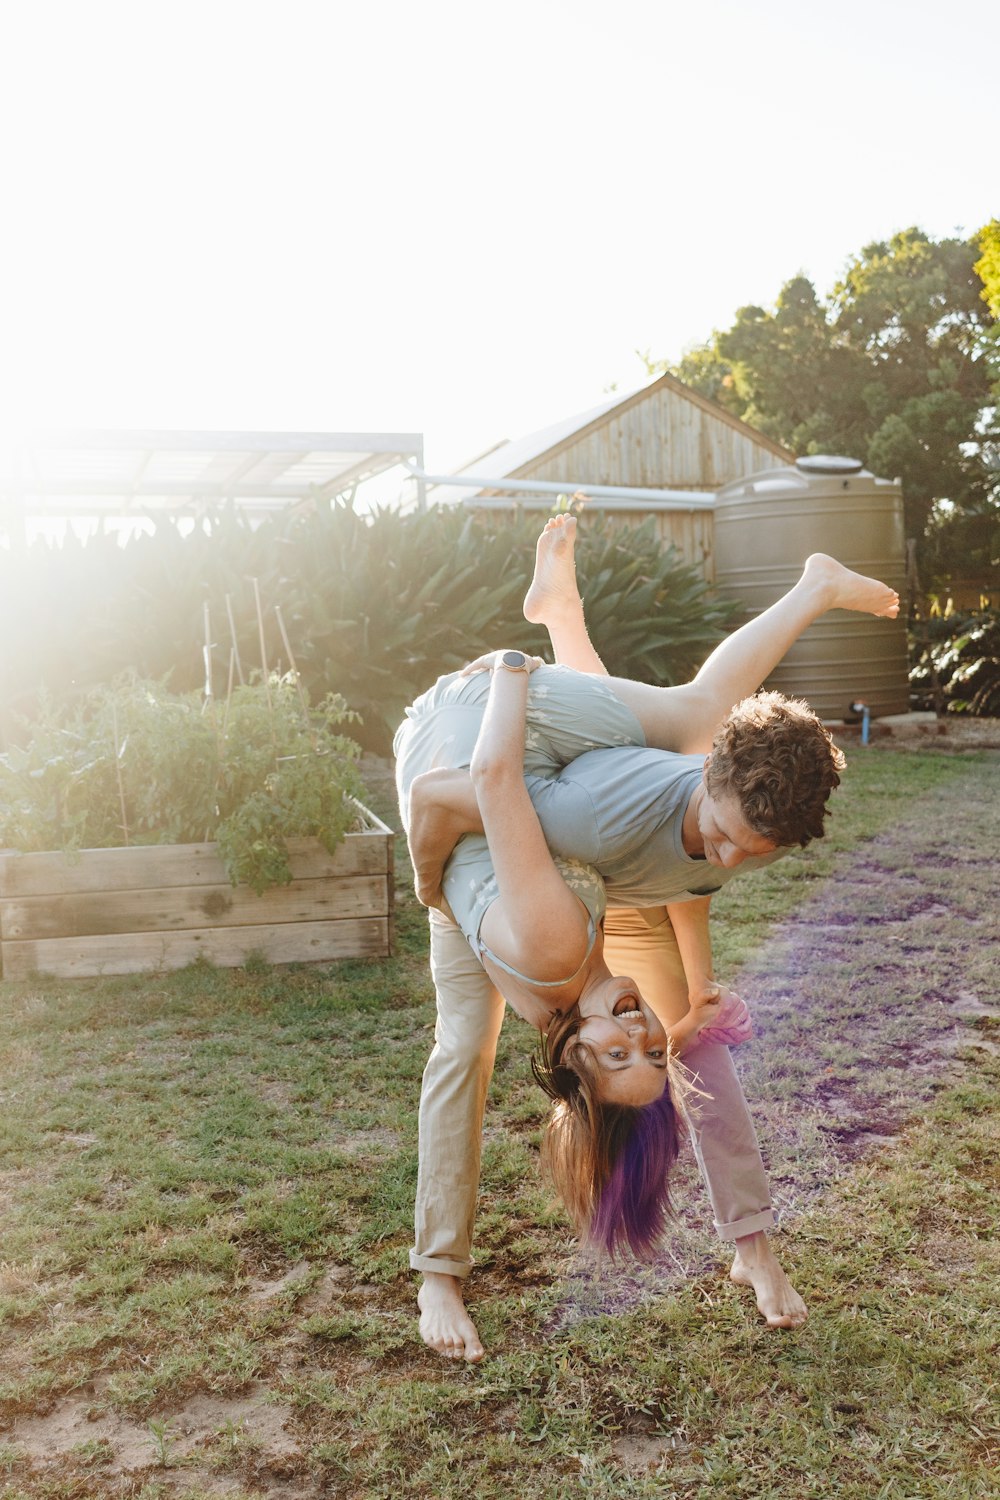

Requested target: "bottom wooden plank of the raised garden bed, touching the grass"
[{"left": 3, "top": 917, "right": 390, "bottom": 980}]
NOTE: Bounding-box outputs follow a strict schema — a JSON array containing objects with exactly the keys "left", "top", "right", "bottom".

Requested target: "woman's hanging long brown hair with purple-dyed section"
[{"left": 531, "top": 1007, "right": 684, "bottom": 1260}]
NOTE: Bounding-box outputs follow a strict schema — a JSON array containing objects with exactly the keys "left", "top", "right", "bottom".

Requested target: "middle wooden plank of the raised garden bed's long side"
[{"left": 0, "top": 875, "right": 390, "bottom": 942}]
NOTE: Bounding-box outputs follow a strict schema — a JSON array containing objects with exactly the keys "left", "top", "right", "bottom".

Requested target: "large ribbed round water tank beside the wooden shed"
[{"left": 715, "top": 455, "right": 910, "bottom": 719}]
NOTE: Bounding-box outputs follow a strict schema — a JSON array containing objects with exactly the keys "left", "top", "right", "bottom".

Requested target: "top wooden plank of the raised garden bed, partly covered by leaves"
[{"left": 0, "top": 825, "right": 393, "bottom": 900}]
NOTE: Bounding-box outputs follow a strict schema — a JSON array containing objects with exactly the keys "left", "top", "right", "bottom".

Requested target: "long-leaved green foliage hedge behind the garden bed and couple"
[{"left": 0, "top": 504, "right": 729, "bottom": 752}]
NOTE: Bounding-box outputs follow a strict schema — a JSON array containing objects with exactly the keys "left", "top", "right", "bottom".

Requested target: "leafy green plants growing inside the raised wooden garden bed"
[{"left": 0, "top": 674, "right": 363, "bottom": 893}]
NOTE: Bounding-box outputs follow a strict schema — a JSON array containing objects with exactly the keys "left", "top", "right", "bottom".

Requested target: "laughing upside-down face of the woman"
[{"left": 577, "top": 977, "right": 669, "bottom": 1106}]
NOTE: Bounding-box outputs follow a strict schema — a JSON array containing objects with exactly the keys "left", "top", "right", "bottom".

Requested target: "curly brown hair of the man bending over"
[{"left": 705, "top": 693, "right": 844, "bottom": 849}]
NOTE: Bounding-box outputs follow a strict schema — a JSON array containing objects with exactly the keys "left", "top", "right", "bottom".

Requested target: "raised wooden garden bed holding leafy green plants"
[{"left": 0, "top": 809, "right": 394, "bottom": 980}]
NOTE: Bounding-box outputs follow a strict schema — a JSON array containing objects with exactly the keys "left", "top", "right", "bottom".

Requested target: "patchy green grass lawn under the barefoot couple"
[{"left": 0, "top": 749, "right": 1000, "bottom": 1500}]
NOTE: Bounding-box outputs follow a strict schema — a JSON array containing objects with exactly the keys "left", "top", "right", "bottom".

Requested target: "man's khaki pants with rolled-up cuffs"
[{"left": 409, "top": 908, "right": 775, "bottom": 1277}]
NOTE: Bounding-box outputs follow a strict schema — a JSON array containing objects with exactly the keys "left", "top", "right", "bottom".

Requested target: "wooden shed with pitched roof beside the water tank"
[{"left": 427, "top": 375, "right": 795, "bottom": 582}]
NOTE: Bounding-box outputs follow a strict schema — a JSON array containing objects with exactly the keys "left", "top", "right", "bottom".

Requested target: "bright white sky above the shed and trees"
[{"left": 0, "top": 0, "right": 1000, "bottom": 486}]
